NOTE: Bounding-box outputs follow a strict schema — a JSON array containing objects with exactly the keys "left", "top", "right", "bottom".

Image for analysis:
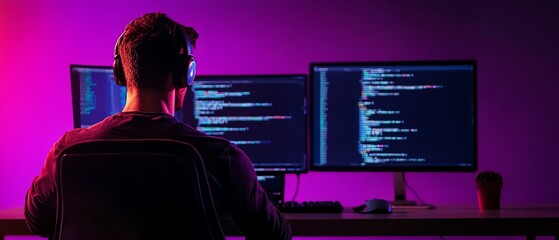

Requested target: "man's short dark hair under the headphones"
[{"left": 118, "top": 13, "right": 198, "bottom": 91}]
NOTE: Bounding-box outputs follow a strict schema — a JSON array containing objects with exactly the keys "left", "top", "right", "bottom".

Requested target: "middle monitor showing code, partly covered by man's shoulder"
[{"left": 183, "top": 74, "right": 308, "bottom": 174}]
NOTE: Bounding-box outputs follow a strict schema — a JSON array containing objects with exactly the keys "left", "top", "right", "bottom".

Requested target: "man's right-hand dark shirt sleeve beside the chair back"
[{"left": 226, "top": 145, "right": 292, "bottom": 240}]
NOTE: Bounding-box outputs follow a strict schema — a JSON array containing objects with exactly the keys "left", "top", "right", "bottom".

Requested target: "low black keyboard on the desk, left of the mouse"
[{"left": 277, "top": 201, "right": 344, "bottom": 213}]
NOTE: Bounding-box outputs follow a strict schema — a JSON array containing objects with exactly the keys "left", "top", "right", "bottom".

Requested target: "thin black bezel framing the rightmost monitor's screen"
[{"left": 308, "top": 59, "right": 478, "bottom": 172}]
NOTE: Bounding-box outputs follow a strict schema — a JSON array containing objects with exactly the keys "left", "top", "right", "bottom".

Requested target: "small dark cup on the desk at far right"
[{"left": 476, "top": 171, "right": 503, "bottom": 211}]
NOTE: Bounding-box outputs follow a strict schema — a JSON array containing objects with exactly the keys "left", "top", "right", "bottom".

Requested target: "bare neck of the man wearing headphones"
[{"left": 122, "top": 89, "right": 175, "bottom": 115}]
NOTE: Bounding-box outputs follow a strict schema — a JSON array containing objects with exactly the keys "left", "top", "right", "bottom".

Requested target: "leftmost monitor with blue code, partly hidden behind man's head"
[{"left": 70, "top": 65, "right": 183, "bottom": 128}]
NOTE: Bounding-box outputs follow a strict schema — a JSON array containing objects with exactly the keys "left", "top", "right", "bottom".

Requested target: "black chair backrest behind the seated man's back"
[{"left": 54, "top": 139, "right": 225, "bottom": 240}]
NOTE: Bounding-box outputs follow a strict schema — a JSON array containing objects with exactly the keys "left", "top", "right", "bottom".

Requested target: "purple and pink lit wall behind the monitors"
[{"left": 0, "top": 0, "right": 559, "bottom": 239}]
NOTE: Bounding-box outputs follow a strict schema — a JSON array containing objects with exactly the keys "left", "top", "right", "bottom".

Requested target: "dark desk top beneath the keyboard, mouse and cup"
[{"left": 0, "top": 207, "right": 559, "bottom": 240}]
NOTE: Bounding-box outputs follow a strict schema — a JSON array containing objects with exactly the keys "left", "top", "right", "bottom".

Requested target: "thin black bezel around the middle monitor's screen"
[{"left": 188, "top": 73, "right": 311, "bottom": 175}]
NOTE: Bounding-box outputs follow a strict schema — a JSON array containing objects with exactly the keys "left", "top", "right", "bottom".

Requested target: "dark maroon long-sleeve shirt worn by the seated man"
[{"left": 25, "top": 112, "right": 291, "bottom": 239}]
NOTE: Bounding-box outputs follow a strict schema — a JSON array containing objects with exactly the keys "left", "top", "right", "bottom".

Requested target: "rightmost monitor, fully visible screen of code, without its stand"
[{"left": 310, "top": 60, "right": 477, "bottom": 172}]
